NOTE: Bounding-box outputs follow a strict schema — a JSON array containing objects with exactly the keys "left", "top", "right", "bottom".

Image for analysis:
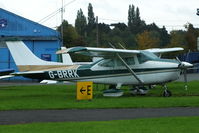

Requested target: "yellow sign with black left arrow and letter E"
[{"left": 77, "top": 81, "right": 93, "bottom": 100}]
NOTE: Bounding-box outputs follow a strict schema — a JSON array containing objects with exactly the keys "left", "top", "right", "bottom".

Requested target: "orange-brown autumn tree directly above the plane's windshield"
[{"left": 136, "top": 31, "right": 160, "bottom": 49}]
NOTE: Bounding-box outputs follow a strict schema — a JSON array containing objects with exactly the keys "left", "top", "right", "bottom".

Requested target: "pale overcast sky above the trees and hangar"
[{"left": 0, "top": 0, "right": 199, "bottom": 30}]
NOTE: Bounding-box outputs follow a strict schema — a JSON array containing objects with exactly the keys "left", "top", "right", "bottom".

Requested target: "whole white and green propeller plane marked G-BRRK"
[{"left": 2, "top": 41, "right": 193, "bottom": 96}]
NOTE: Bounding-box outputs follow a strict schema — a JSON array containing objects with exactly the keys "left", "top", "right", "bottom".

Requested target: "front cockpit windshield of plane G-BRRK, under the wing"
[{"left": 137, "top": 51, "right": 159, "bottom": 63}]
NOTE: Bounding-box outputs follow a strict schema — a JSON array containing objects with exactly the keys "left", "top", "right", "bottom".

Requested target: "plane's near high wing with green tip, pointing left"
[{"left": 57, "top": 47, "right": 140, "bottom": 58}]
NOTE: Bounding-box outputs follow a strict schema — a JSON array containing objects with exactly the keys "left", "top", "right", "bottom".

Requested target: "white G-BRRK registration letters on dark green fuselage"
[{"left": 48, "top": 69, "right": 79, "bottom": 79}]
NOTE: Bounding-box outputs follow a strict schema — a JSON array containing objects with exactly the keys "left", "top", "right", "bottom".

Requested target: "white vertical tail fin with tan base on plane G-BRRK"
[{"left": 6, "top": 41, "right": 69, "bottom": 71}]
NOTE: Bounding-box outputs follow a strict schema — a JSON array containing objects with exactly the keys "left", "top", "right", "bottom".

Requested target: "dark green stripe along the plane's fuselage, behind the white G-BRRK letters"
[{"left": 42, "top": 59, "right": 179, "bottom": 80}]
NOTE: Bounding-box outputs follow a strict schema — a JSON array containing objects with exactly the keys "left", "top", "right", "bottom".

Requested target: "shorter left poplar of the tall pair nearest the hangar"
[{"left": 75, "top": 8, "right": 87, "bottom": 37}]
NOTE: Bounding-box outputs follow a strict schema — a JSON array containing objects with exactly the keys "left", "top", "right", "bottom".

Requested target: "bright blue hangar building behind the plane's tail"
[{"left": 0, "top": 8, "right": 61, "bottom": 80}]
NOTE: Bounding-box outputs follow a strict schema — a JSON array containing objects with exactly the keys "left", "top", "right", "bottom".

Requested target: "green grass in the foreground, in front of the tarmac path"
[{"left": 0, "top": 117, "right": 199, "bottom": 133}]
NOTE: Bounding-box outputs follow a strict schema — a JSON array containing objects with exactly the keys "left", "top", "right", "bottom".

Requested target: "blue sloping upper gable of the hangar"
[{"left": 0, "top": 8, "right": 60, "bottom": 40}]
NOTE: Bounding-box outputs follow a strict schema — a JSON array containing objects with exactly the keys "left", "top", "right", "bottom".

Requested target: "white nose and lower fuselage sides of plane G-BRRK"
[{"left": 74, "top": 61, "right": 181, "bottom": 85}]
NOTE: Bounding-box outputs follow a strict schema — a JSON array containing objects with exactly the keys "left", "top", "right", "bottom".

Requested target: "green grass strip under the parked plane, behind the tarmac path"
[{"left": 0, "top": 81, "right": 199, "bottom": 110}]
